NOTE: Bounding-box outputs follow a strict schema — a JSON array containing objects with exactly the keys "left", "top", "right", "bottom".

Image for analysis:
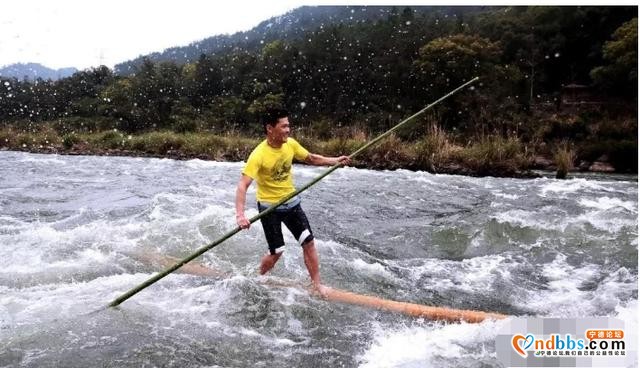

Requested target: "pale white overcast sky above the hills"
[{"left": 0, "top": 0, "right": 635, "bottom": 69}]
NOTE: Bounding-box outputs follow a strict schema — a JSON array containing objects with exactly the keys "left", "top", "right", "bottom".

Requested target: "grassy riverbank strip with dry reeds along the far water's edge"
[{"left": 0, "top": 127, "right": 615, "bottom": 178}]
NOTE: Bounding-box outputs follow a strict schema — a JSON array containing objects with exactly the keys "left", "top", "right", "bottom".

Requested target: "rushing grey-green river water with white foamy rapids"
[{"left": 0, "top": 152, "right": 638, "bottom": 367}]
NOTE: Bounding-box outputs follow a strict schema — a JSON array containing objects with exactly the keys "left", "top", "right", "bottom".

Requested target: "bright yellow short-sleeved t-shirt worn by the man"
[{"left": 242, "top": 138, "right": 309, "bottom": 204}]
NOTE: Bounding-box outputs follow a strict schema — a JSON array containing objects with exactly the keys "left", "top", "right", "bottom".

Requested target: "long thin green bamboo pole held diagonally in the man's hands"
[{"left": 108, "top": 77, "right": 479, "bottom": 307}]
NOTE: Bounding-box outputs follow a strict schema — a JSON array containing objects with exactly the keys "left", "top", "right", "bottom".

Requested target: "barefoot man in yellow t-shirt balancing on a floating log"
[{"left": 236, "top": 109, "right": 350, "bottom": 295}]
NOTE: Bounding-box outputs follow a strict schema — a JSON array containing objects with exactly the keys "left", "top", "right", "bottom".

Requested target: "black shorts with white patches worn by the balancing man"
[{"left": 258, "top": 203, "right": 313, "bottom": 254}]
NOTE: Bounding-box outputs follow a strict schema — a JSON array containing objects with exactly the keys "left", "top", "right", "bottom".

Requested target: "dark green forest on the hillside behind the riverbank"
[{"left": 0, "top": 6, "right": 638, "bottom": 171}]
